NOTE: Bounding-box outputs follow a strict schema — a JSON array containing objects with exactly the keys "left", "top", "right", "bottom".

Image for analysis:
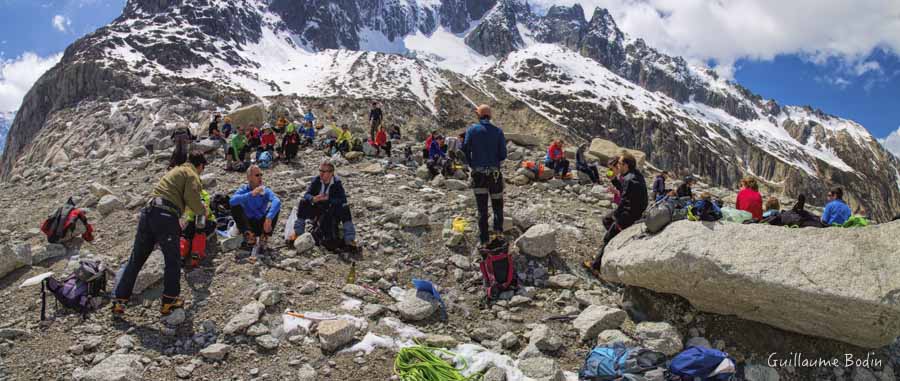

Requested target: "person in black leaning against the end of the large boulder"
[{"left": 584, "top": 152, "right": 649, "bottom": 272}]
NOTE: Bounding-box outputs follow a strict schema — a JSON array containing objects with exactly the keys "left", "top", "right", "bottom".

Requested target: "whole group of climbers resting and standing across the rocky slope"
[{"left": 113, "top": 95, "right": 876, "bottom": 320}]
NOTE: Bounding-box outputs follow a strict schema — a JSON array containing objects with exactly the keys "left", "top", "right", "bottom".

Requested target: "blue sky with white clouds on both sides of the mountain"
[{"left": 0, "top": 0, "right": 900, "bottom": 138}]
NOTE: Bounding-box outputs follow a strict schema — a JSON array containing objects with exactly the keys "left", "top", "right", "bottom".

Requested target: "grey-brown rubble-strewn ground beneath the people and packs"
[{"left": 0, "top": 134, "right": 900, "bottom": 381}]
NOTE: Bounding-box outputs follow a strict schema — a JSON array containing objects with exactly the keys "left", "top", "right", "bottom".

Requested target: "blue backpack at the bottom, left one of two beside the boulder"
[{"left": 578, "top": 342, "right": 666, "bottom": 381}]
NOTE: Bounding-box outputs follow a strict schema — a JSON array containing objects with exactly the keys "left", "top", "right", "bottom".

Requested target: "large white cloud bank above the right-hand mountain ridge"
[{"left": 530, "top": 0, "right": 900, "bottom": 75}]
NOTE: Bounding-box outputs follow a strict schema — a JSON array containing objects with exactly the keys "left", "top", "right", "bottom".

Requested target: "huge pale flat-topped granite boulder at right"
[{"left": 602, "top": 221, "right": 900, "bottom": 348}]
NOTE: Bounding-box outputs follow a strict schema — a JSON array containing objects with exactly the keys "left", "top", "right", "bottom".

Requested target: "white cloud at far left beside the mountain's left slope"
[{"left": 0, "top": 52, "right": 62, "bottom": 111}]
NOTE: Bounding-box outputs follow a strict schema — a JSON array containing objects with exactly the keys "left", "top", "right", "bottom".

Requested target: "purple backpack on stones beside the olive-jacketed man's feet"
[{"left": 41, "top": 261, "right": 106, "bottom": 320}]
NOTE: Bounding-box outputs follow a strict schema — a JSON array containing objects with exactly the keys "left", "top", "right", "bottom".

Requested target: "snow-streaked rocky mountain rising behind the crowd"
[{"left": 0, "top": 0, "right": 900, "bottom": 219}]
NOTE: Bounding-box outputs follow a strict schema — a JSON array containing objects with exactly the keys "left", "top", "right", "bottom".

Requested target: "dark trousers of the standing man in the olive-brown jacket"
[{"left": 113, "top": 207, "right": 181, "bottom": 299}]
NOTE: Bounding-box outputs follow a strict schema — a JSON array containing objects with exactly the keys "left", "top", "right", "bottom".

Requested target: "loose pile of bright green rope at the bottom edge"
[{"left": 394, "top": 345, "right": 481, "bottom": 381}]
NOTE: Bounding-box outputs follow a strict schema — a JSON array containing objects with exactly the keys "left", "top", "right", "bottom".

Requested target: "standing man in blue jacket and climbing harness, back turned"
[{"left": 462, "top": 105, "right": 506, "bottom": 245}]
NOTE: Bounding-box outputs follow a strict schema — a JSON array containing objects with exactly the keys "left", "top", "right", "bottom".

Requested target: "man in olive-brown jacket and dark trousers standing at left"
[{"left": 112, "top": 151, "right": 206, "bottom": 316}]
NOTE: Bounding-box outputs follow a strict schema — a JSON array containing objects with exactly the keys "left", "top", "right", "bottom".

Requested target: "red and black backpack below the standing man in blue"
[{"left": 478, "top": 237, "right": 518, "bottom": 303}]
